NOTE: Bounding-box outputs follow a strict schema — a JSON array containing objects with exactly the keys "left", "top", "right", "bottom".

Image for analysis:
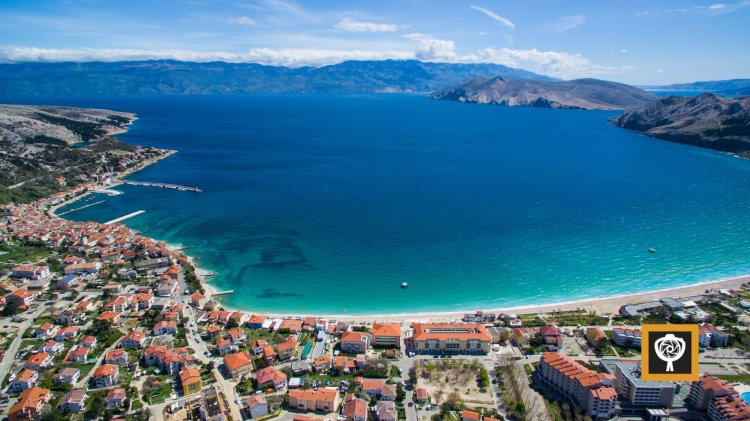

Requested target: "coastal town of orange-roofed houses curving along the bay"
[{"left": 0, "top": 158, "right": 750, "bottom": 421}]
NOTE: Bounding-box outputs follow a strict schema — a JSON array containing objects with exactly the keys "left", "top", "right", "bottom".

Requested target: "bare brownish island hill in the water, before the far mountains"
[{"left": 431, "top": 77, "right": 656, "bottom": 110}]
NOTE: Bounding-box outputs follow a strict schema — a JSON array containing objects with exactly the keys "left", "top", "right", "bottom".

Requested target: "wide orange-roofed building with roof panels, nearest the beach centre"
[{"left": 412, "top": 323, "right": 492, "bottom": 354}]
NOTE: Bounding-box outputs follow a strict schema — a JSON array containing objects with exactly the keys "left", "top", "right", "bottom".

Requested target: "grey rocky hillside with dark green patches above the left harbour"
[{"left": 0, "top": 105, "right": 136, "bottom": 203}]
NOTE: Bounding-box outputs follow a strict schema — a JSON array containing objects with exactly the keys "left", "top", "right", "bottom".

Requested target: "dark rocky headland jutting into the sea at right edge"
[{"left": 612, "top": 93, "right": 750, "bottom": 157}]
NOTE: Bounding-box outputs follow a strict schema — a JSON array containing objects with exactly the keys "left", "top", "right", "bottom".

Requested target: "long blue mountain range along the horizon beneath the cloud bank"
[{"left": 0, "top": 60, "right": 554, "bottom": 96}]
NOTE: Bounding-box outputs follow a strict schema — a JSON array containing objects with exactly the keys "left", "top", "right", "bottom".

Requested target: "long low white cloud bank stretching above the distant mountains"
[{"left": 0, "top": 44, "right": 634, "bottom": 79}]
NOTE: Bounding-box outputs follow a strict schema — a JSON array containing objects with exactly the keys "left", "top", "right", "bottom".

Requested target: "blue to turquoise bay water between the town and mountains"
[{"left": 8, "top": 95, "right": 750, "bottom": 314}]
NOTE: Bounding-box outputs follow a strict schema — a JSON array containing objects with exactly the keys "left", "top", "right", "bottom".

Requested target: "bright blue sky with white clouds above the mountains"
[{"left": 0, "top": 0, "right": 750, "bottom": 85}]
